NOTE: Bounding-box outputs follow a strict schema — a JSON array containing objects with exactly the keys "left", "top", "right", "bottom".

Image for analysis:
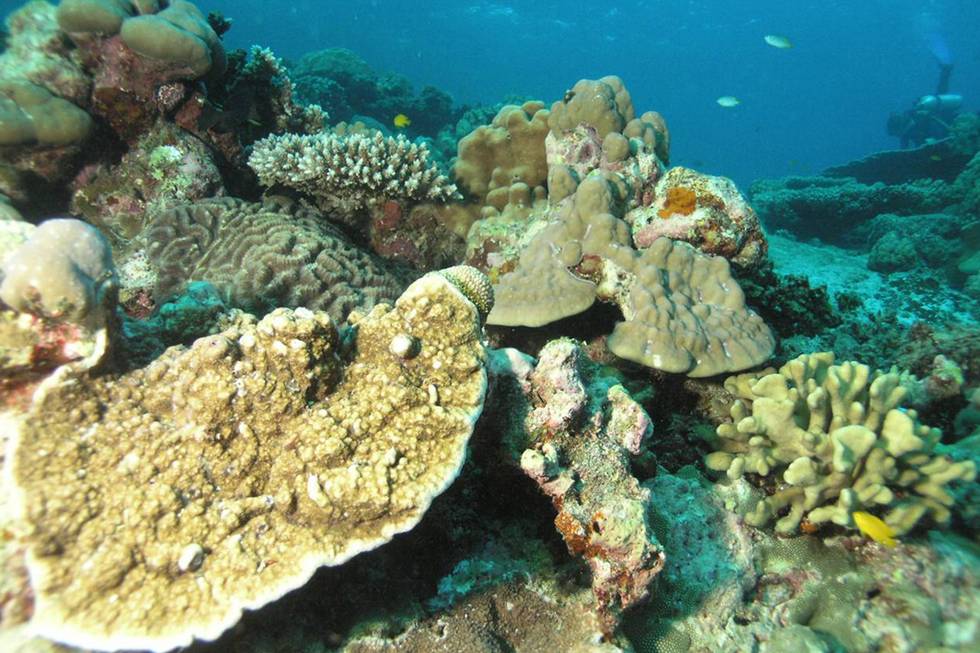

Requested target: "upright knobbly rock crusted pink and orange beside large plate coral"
[{"left": 521, "top": 339, "right": 664, "bottom": 634}]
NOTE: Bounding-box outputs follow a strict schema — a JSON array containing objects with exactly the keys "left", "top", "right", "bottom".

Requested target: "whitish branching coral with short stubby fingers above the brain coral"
[{"left": 248, "top": 132, "right": 456, "bottom": 221}]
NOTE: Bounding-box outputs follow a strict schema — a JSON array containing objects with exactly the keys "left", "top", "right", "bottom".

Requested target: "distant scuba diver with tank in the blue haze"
[{"left": 888, "top": 42, "right": 963, "bottom": 148}]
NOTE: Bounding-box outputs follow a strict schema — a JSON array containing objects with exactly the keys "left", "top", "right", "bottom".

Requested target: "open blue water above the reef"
[{"left": 200, "top": 0, "right": 980, "bottom": 184}]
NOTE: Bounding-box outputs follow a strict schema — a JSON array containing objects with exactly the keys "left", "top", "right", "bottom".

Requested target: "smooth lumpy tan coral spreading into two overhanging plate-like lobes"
[{"left": 488, "top": 176, "right": 775, "bottom": 377}]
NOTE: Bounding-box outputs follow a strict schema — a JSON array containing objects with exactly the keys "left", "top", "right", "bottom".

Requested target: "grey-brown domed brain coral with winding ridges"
[{"left": 141, "top": 198, "right": 402, "bottom": 321}]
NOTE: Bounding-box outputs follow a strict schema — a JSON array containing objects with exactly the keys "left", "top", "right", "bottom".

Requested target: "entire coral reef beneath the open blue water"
[{"left": 0, "top": 0, "right": 980, "bottom": 653}]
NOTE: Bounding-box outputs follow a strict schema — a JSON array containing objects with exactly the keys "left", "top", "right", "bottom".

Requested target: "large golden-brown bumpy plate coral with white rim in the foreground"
[{"left": 10, "top": 273, "right": 487, "bottom": 651}]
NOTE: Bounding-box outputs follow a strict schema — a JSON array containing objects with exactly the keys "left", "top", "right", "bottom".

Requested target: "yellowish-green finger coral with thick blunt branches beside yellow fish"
[{"left": 705, "top": 353, "right": 976, "bottom": 535}]
